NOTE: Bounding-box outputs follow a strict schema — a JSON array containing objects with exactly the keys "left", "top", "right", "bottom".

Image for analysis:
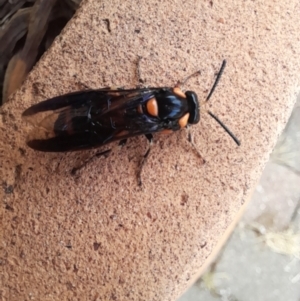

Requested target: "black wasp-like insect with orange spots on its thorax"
[{"left": 23, "top": 60, "right": 239, "bottom": 183}]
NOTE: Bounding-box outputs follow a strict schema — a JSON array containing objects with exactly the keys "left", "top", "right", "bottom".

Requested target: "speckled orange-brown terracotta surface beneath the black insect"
[{"left": 0, "top": 0, "right": 300, "bottom": 301}]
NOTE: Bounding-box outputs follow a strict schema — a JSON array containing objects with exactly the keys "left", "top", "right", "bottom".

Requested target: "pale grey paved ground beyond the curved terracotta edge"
[{"left": 178, "top": 96, "right": 300, "bottom": 301}]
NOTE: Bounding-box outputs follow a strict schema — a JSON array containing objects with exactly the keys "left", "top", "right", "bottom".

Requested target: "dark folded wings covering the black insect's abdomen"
[{"left": 23, "top": 89, "right": 156, "bottom": 152}]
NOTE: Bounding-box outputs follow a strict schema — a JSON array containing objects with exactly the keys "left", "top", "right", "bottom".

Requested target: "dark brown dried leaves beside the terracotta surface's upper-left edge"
[{"left": 0, "top": 0, "right": 81, "bottom": 106}]
